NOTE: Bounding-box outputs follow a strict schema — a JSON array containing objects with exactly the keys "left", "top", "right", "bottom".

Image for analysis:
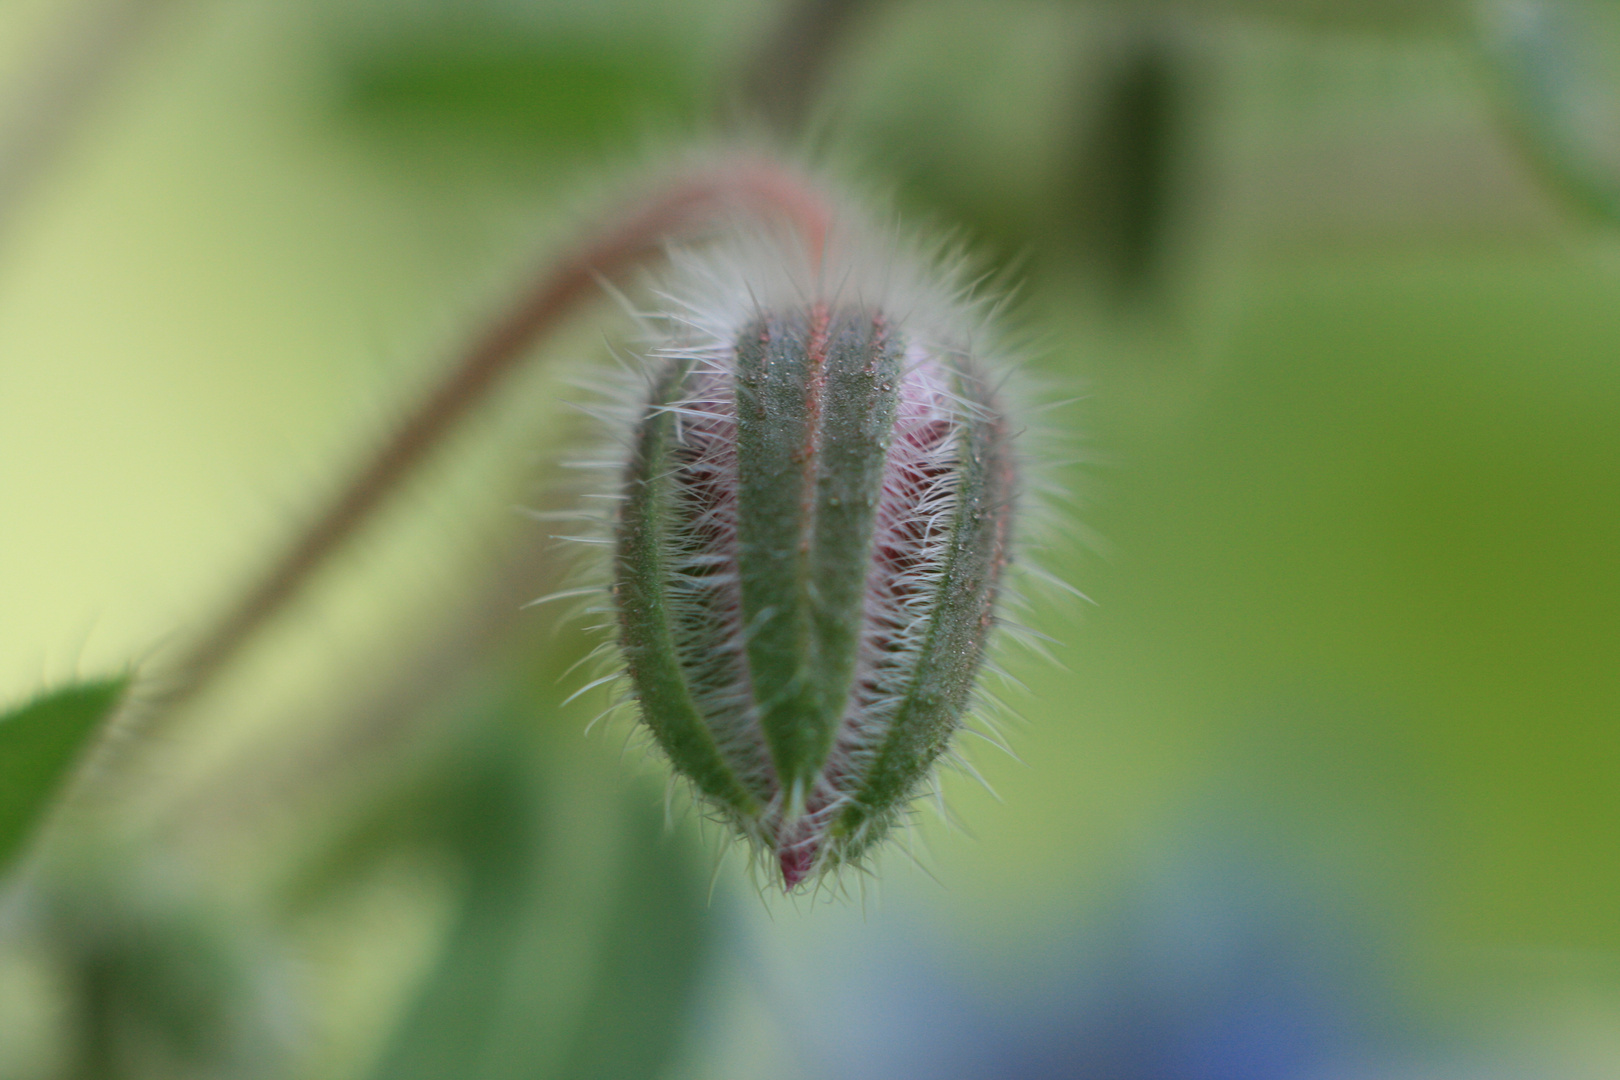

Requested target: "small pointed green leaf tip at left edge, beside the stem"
[{"left": 0, "top": 675, "right": 130, "bottom": 873}]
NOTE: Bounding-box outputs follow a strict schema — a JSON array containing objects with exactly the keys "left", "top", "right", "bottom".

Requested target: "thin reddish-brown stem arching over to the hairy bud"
[{"left": 162, "top": 159, "right": 831, "bottom": 712}]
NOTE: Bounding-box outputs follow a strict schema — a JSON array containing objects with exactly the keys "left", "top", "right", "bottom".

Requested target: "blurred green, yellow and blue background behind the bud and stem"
[{"left": 0, "top": 0, "right": 1620, "bottom": 1080}]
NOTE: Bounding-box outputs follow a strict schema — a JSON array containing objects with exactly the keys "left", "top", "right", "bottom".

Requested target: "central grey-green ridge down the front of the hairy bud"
[{"left": 735, "top": 304, "right": 899, "bottom": 808}]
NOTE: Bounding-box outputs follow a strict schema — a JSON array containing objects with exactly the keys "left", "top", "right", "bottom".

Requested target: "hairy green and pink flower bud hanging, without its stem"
[{"left": 612, "top": 226, "right": 1016, "bottom": 889}]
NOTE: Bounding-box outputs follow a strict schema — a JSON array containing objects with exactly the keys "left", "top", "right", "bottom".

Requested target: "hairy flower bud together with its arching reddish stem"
[{"left": 3, "top": 155, "right": 1017, "bottom": 889}]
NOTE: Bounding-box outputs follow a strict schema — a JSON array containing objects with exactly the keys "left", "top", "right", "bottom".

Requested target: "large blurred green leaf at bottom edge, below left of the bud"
[{"left": 373, "top": 709, "right": 706, "bottom": 1080}]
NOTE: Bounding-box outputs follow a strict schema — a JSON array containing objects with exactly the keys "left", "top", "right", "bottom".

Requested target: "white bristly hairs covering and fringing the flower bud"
[{"left": 535, "top": 187, "right": 1072, "bottom": 893}]
